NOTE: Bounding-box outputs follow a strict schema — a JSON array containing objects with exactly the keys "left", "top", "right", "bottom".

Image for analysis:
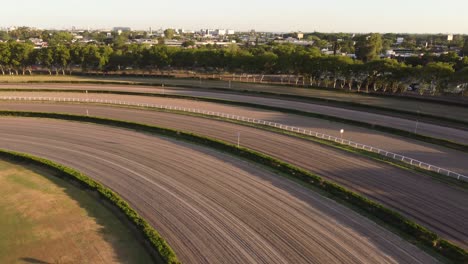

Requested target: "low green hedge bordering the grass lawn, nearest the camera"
[{"left": 0, "top": 149, "right": 180, "bottom": 264}]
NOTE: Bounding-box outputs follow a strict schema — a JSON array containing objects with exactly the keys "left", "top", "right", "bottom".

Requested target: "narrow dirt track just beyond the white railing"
[{"left": 0, "top": 92, "right": 468, "bottom": 175}]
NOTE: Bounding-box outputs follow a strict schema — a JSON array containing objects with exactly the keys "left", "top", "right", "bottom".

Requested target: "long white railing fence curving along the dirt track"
[{"left": 0, "top": 96, "right": 468, "bottom": 182}]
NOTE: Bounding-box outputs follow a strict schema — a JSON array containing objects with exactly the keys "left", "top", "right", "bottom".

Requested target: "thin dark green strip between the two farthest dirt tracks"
[{"left": 0, "top": 89, "right": 468, "bottom": 152}]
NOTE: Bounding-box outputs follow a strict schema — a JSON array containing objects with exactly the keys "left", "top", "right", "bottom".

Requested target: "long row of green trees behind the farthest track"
[{"left": 0, "top": 40, "right": 468, "bottom": 93}]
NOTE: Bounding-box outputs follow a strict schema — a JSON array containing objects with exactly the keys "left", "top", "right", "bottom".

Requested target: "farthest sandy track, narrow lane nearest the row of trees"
[{"left": 0, "top": 84, "right": 468, "bottom": 144}]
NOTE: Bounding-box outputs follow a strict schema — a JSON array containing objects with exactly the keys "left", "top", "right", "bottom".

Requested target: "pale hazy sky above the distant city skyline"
[{"left": 0, "top": 0, "right": 468, "bottom": 34}]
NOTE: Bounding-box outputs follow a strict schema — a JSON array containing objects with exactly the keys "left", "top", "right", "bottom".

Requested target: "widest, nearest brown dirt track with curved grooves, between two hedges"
[{"left": 0, "top": 118, "right": 435, "bottom": 263}]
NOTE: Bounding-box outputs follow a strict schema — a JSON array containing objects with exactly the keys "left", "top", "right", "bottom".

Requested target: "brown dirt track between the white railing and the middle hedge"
[{"left": 2, "top": 104, "right": 468, "bottom": 248}]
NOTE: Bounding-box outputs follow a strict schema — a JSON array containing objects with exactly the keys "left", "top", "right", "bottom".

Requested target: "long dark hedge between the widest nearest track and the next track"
[{"left": 0, "top": 111, "right": 468, "bottom": 263}]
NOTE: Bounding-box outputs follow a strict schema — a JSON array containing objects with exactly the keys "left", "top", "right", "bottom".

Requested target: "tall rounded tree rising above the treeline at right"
[{"left": 356, "top": 33, "right": 382, "bottom": 62}]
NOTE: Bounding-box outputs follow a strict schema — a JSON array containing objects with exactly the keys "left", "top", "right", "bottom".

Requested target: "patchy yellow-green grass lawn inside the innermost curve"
[{"left": 0, "top": 160, "right": 152, "bottom": 263}]
